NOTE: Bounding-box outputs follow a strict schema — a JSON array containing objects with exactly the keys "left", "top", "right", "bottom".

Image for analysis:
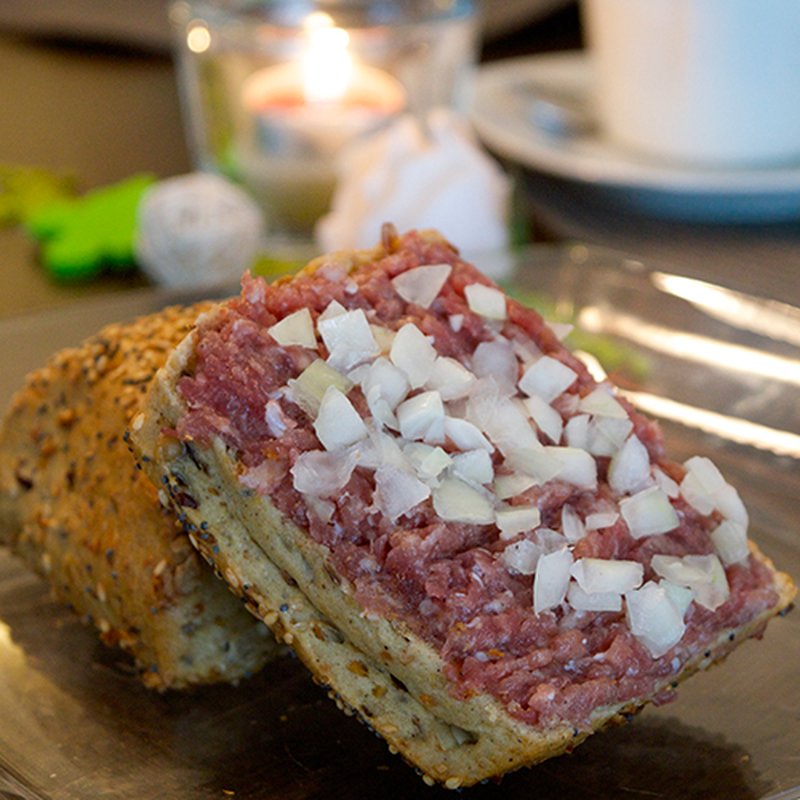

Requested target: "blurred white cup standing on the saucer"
[{"left": 583, "top": 0, "right": 800, "bottom": 167}]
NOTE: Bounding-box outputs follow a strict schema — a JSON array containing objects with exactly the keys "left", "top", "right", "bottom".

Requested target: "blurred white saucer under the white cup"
[{"left": 471, "top": 52, "right": 800, "bottom": 222}]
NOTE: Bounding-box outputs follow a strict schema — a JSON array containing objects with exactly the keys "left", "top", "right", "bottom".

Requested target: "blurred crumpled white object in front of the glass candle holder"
[{"left": 315, "top": 109, "right": 511, "bottom": 253}]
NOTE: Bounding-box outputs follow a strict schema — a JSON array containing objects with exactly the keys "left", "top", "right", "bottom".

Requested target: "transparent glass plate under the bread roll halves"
[{"left": 0, "top": 246, "right": 800, "bottom": 800}]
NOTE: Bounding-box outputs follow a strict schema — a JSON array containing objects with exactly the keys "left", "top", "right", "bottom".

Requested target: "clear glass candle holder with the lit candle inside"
[{"left": 170, "top": 0, "right": 477, "bottom": 248}]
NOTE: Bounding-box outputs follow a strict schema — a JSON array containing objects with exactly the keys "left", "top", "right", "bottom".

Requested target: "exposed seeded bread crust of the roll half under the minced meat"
[{"left": 132, "top": 239, "right": 795, "bottom": 788}]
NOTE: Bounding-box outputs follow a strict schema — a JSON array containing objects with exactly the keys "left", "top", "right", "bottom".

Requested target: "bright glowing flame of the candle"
[{"left": 301, "top": 11, "right": 353, "bottom": 103}]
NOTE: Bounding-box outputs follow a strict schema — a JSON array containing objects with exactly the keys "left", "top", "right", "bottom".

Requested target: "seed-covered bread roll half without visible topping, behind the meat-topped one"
[{"left": 0, "top": 306, "right": 277, "bottom": 689}]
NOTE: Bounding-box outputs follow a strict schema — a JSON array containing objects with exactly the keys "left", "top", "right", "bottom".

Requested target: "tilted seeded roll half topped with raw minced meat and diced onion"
[{"left": 132, "top": 228, "right": 795, "bottom": 788}]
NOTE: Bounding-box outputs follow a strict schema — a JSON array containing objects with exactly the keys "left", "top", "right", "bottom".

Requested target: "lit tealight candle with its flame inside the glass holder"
[{"left": 239, "top": 12, "right": 406, "bottom": 234}]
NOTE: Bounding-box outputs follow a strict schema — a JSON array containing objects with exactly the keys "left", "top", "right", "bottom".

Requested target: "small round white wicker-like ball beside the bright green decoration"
[{"left": 135, "top": 172, "right": 265, "bottom": 287}]
